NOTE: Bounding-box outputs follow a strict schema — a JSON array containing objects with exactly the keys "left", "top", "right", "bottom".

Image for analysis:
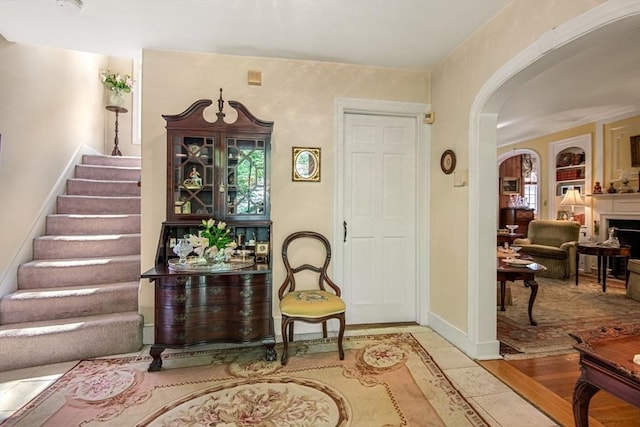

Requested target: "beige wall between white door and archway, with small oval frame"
[{"left": 430, "top": 0, "right": 602, "bottom": 332}]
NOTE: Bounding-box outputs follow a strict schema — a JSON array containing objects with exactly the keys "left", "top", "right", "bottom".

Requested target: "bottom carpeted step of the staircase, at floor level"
[{"left": 0, "top": 311, "right": 143, "bottom": 371}]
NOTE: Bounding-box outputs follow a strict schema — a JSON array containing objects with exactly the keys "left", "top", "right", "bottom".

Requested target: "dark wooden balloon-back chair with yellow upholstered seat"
[{"left": 278, "top": 231, "right": 346, "bottom": 365}]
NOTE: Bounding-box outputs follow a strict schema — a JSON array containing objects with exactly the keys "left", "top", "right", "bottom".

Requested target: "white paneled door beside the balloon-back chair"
[{"left": 343, "top": 114, "right": 417, "bottom": 324}]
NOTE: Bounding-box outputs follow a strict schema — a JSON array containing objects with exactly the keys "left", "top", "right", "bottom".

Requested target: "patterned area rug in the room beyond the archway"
[{"left": 498, "top": 275, "right": 640, "bottom": 359}]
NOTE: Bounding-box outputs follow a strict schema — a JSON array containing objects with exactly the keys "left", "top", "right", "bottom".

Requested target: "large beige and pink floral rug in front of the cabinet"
[{"left": 0, "top": 334, "right": 488, "bottom": 427}]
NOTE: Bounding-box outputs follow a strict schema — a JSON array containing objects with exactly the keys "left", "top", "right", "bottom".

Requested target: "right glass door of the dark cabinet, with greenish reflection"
[{"left": 225, "top": 138, "right": 268, "bottom": 217}]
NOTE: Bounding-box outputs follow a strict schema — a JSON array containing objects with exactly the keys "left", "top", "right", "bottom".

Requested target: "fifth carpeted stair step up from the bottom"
[{"left": 46, "top": 214, "right": 141, "bottom": 236}]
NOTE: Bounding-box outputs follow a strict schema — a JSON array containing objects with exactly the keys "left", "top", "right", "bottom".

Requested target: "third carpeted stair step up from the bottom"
[{"left": 18, "top": 255, "right": 140, "bottom": 290}]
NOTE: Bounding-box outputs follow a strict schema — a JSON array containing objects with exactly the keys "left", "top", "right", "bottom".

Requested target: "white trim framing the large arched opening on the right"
[{"left": 467, "top": 2, "right": 640, "bottom": 360}]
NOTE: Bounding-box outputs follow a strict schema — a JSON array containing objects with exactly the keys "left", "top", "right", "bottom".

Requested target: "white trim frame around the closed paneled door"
[{"left": 332, "top": 98, "right": 431, "bottom": 325}]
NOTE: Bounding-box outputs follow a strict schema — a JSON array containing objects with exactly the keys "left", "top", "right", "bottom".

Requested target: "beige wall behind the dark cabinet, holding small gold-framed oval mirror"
[{"left": 140, "top": 50, "right": 429, "bottom": 323}]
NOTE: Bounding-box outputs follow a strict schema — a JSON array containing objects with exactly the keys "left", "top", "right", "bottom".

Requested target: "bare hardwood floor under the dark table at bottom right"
[{"left": 478, "top": 353, "right": 640, "bottom": 427}]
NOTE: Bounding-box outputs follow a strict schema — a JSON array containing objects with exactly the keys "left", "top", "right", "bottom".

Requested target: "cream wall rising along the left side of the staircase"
[{"left": 0, "top": 37, "right": 107, "bottom": 295}]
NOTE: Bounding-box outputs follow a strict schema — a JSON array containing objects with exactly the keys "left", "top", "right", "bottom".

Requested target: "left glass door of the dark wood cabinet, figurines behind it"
[{"left": 172, "top": 135, "right": 215, "bottom": 216}]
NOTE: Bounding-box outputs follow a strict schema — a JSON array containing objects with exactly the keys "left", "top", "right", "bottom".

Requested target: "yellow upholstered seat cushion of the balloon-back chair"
[{"left": 280, "top": 290, "right": 346, "bottom": 319}]
